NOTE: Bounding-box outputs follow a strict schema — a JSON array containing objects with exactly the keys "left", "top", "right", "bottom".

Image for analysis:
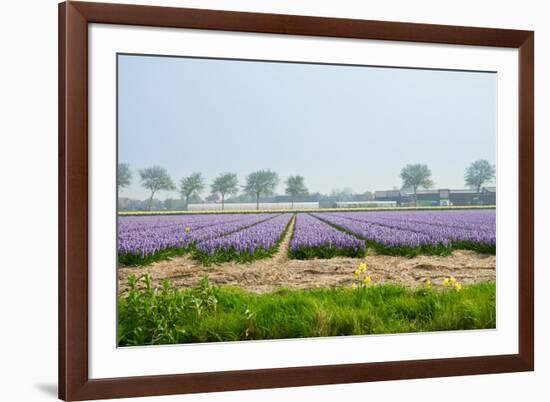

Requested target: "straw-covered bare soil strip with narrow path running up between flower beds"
[{"left": 118, "top": 218, "right": 496, "bottom": 293}]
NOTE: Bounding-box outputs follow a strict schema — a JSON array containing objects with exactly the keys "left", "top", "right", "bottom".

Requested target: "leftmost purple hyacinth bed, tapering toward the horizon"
[{"left": 118, "top": 214, "right": 274, "bottom": 258}]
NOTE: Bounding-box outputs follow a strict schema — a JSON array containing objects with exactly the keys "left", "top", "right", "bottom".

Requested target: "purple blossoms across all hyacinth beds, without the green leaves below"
[{"left": 118, "top": 210, "right": 496, "bottom": 258}]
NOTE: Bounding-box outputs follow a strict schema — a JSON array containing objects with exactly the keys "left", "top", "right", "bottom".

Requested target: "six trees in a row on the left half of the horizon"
[{"left": 118, "top": 163, "right": 308, "bottom": 210}]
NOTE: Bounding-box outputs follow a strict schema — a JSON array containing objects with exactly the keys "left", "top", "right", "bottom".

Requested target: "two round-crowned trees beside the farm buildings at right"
[{"left": 401, "top": 159, "right": 496, "bottom": 205}]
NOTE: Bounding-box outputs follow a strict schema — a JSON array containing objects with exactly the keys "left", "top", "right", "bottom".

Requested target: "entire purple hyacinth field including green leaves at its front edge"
[{"left": 118, "top": 209, "right": 496, "bottom": 265}]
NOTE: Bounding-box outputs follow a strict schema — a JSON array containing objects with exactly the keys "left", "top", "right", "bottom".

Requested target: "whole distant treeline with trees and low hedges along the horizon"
[{"left": 117, "top": 159, "right": 496, "bottom": 211}]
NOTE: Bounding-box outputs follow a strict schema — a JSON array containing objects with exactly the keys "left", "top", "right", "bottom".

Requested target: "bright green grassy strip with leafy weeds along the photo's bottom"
[{"left": 118, "top": 276, "right": 496, "bottom": 346}]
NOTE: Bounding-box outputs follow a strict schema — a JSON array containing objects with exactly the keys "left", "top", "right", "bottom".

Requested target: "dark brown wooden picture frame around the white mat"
[{"left": 59, "top": 1, "right": 534, "bottom": 400}]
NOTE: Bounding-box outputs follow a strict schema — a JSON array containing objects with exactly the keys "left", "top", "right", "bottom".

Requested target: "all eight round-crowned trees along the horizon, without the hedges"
[{"left": 118, "top": 159, "right": 496, "bottom": 210}]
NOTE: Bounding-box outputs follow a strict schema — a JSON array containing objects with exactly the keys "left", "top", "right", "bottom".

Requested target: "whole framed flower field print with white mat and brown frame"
[{"left": 59, "top": 2, "right": 534, "bottom": 400}]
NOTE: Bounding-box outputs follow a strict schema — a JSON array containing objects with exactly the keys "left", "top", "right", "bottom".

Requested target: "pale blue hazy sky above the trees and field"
[{"left": 118, "top": 55, "right": 497, "bottom": 199}]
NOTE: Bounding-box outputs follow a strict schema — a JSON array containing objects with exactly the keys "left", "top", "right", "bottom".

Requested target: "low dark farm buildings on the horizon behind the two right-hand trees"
[{"left": 374, "top": 187, "right": 496, "bottom": 206}]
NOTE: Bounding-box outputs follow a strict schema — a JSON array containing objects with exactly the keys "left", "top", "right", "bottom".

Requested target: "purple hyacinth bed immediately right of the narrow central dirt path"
[{"left": 290, "top": 214, "right": 365, "bottom": 254}]
